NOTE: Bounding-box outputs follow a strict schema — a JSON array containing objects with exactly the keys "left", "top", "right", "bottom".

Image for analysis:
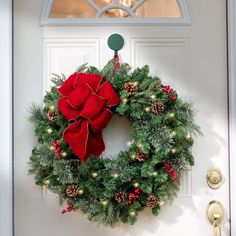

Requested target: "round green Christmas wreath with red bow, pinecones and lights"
[{"left": 29, "top": 60, "right": 200, "bottom": 225}]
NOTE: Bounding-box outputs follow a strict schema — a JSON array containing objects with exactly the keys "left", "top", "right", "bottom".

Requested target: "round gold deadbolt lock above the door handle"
[{"left": 206, "top": 168, "right": 222, "bottom": 189}]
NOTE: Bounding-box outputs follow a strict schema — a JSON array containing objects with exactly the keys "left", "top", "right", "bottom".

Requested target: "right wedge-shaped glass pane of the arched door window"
[{"left": 136, "top": 0, "right": 181, "bottom": 18}]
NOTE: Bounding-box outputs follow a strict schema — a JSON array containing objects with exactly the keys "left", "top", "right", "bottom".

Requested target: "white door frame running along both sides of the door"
[{"left": 0, "top": 0, "right": 236, "bottom": 236}]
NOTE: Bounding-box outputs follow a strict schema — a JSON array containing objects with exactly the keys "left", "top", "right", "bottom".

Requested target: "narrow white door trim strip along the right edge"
[{"left": 227, "top": 0, "right": 236, "bottom": 235}]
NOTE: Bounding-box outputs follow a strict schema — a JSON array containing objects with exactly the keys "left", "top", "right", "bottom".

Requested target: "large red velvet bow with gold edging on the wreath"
[{"left": 58, "top": 73, "right": 120, "bottom": 162}]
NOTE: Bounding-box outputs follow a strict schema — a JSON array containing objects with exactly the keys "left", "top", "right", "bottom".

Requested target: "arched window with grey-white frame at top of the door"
[{"left": 41, "top": 0, "right": 190, "bottom": 25}]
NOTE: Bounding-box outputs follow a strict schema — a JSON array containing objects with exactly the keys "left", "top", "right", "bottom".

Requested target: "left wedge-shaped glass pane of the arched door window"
[{"left": 50, "top": 0, "right": 96, "bottom": 18}]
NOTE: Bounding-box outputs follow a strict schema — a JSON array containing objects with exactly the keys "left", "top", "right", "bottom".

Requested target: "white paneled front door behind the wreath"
[{"left": 14, "top": 0, "right": 230, "bottom": 236}]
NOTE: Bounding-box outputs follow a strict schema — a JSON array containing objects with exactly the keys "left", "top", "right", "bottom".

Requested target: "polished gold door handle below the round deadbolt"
[{"left": 206, "top": 200, "right": 224, "bottom": 236}]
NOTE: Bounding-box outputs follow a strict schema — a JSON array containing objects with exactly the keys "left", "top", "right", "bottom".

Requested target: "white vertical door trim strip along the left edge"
[{"left": 0, "top": 0, "right": 14, "bottom": 236}]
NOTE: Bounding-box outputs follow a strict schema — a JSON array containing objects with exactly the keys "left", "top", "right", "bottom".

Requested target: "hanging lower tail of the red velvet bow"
[{"left": 63, "top": 108, "right": 112, "bottom": 162}]
